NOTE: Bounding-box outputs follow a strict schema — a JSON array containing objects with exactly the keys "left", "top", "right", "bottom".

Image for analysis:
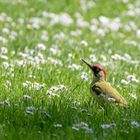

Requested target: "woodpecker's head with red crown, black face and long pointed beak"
[{"left": 81, "top": 59, "right": 106, "bottom": 80}]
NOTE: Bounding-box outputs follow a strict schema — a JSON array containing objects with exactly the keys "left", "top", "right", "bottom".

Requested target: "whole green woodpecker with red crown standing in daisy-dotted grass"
[{"left": 82, "top": 59, "right": 128, "bottom": 107}]
